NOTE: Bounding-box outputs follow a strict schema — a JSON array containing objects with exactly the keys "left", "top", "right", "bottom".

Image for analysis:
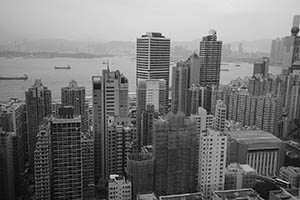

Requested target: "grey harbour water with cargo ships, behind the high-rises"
[{"left": 0, "top": 56, "right": 281, "bottom": 102}]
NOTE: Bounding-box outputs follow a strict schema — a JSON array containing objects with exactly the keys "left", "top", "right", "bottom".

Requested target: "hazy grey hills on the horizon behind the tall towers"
[{"left": 0, "top": 38, "right": 271, "bottom": 58}]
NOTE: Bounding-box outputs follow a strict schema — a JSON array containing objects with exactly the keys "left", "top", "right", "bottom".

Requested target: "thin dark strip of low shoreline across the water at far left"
[{"left": 0, "top": 51, "right": 115, "bottom": 59}]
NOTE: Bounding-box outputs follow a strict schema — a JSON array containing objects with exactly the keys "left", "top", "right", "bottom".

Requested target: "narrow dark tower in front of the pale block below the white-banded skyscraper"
[{"left": 141, "top": 104, "right": 158, "bottom": 146}]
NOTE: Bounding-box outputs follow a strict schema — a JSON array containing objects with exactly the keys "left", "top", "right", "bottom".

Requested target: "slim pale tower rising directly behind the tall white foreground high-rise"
[{"left": 214, "top": 100, "right": 226, "bottom": 132}]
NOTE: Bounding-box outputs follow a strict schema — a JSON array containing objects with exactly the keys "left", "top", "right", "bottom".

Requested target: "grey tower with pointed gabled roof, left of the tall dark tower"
[{"left": 186, "top": 53, "right": 201, "bottom": 87}]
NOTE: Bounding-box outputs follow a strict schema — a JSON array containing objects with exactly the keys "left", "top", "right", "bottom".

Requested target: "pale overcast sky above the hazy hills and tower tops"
[{"left": 0, "top": 0, "right": 300, "bottom": 43}]
